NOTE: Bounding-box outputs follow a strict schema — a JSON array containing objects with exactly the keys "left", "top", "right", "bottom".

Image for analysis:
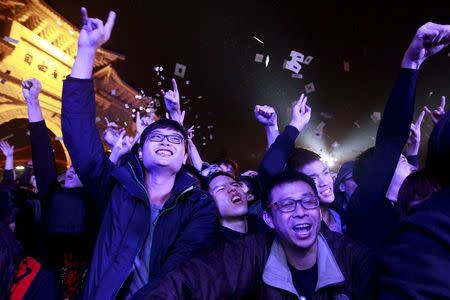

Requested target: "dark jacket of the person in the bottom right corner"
[{"left": 379, "top": 189, "right": 450, "bottom": 299}]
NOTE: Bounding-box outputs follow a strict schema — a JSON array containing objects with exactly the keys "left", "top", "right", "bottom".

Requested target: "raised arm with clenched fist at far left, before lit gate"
[{"left": 22, "top": 78, "right": 59, "bottom": 199}]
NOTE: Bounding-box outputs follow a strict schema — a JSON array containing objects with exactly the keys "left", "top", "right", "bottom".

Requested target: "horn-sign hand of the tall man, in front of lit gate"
[{"left": 78, "top": 7, "right": 116, "bottom": 49}]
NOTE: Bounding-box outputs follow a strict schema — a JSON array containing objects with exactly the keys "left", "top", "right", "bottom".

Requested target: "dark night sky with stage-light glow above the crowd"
[{"left": 48, "top": 0, "right": 450, "bottom": 168}]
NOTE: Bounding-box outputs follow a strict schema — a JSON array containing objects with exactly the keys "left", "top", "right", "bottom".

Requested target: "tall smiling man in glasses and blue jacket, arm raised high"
[{"left": 62, "top": 8, "right": 217, "bottom": 299}]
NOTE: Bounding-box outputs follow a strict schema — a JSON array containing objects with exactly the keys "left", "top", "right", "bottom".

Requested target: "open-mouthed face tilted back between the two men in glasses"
[{"left": 208, "top": 175, "right": 248, "bottom": 219}]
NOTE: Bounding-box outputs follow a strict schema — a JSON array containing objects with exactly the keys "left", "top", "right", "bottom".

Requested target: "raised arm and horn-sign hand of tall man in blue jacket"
[{"left": 61, "top": 8, "right": 115, "bottom": 209}]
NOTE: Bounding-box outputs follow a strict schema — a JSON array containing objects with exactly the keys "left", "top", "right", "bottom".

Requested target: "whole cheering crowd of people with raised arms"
[{"left": 0, "top": 8, "right": 450, "bottom": 300}]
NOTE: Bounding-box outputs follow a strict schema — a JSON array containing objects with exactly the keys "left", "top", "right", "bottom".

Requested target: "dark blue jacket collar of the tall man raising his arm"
[{"left": 112, "top": 155, "right": 195, "bottom": 203}]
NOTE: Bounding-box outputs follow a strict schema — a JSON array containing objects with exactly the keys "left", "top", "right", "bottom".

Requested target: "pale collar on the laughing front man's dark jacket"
[{"left": 263, "top": 234, "right": 345, "bottom": 297}]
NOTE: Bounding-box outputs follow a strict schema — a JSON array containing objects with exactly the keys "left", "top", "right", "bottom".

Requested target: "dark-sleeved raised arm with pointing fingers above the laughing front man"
[{"left": 258, "top": 94, "right": 311, "bottom": 187}]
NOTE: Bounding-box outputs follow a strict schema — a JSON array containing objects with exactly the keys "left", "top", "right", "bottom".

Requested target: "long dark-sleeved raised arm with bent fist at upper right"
[{"left": 348, "top": 23, "right": 450, "bottom": 246}]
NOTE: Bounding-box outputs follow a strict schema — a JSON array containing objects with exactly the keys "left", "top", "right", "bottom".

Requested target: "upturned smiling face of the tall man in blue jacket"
[{"left": 142, "top": 128, "right": 187, "bottom": 173}]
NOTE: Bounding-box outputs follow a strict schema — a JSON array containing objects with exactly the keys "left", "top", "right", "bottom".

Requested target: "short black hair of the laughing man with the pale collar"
[{"left": 261, "top": 170, "right": 318, "bottom": 210}]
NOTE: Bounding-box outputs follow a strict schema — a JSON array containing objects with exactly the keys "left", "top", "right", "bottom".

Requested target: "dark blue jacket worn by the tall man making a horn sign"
[{"left": 62, "top": 78, "right": 216, "bottom": 299}]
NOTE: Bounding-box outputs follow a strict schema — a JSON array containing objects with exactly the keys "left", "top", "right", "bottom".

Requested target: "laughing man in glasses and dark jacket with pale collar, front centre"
[{"left": 139, "top": 171, "right": 374, "bottom": 299}]
